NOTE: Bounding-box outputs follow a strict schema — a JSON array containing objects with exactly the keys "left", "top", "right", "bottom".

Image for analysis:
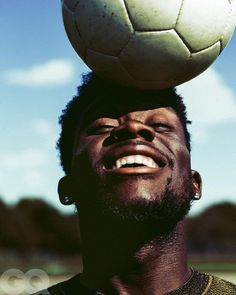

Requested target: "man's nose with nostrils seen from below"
[{"left": 111, "top": 119, "right": 155, "bottom": 142}]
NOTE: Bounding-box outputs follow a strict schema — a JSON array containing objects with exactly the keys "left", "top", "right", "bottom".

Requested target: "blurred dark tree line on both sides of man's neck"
[{"left": 0, "top": 199, "right": 236, "bottom": 255}]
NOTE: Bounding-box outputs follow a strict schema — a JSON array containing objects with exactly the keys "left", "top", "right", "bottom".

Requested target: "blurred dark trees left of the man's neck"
[{"left": 0, "top": 199, "right": 80, "bottom": 255}]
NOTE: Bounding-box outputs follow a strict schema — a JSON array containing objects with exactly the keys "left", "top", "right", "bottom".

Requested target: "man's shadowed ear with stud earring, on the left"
[{"left": 57, "top": 175, "right": 75, "bottom": 205}]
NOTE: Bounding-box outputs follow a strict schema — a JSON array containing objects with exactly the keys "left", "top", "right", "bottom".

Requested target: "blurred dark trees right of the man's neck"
[{"left": 187, "top": 202, "right": 236, "bottom": 259}]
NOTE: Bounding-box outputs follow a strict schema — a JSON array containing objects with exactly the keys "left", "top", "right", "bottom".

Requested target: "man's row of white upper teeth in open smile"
[{"left": 112, "top": 155, "right": 158, "bottom": 169}]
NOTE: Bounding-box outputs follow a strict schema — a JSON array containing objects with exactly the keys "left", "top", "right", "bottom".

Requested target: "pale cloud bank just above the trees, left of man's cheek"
[{"left": 0, "top": 148, "right": 59, "bottom": 203}]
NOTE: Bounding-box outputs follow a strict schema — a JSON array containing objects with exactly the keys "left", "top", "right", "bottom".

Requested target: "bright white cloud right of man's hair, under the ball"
[{"left": 177, "top": 68, "right": 236, "bottom": 143}]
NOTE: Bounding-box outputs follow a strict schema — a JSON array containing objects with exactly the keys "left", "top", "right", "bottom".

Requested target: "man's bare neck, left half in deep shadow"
[{"left": 80, "top": 213, "right": 190, "bottom": 295}]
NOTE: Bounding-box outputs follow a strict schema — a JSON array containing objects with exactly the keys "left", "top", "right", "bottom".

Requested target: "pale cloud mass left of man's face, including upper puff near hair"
[{"left": 0, "top": 118, "right": 62, "bottom": 205}]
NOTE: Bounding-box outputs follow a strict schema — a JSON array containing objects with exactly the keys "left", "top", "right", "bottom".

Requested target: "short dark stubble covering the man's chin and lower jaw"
[{"left": 89, "top": 176, "right": 193, "bottom": 231}]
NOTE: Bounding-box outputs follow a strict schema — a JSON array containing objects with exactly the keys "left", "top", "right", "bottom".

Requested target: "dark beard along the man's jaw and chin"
[{"left": 78, "top": 172, "right": 194, "bottom": 235}]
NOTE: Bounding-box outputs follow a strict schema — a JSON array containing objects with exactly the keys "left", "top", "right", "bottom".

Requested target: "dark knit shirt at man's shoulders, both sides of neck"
[{"left": 34, "top": 271, "right": 236, "bottom": 295}]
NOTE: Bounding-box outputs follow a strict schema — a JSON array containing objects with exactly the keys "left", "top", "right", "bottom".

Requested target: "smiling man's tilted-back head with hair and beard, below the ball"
[{"left": 58, "top": 74, "right": 201, "bottom": 232}]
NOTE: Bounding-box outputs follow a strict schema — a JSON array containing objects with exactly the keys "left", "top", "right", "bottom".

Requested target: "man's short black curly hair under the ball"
[{"left": 57, "top": 72, "right": 191, "bottom": 174}]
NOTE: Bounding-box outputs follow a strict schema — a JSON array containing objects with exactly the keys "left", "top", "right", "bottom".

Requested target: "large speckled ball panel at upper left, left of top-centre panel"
[{"left": 75, "top": 0, "right": 133, "bottom": 56}]
